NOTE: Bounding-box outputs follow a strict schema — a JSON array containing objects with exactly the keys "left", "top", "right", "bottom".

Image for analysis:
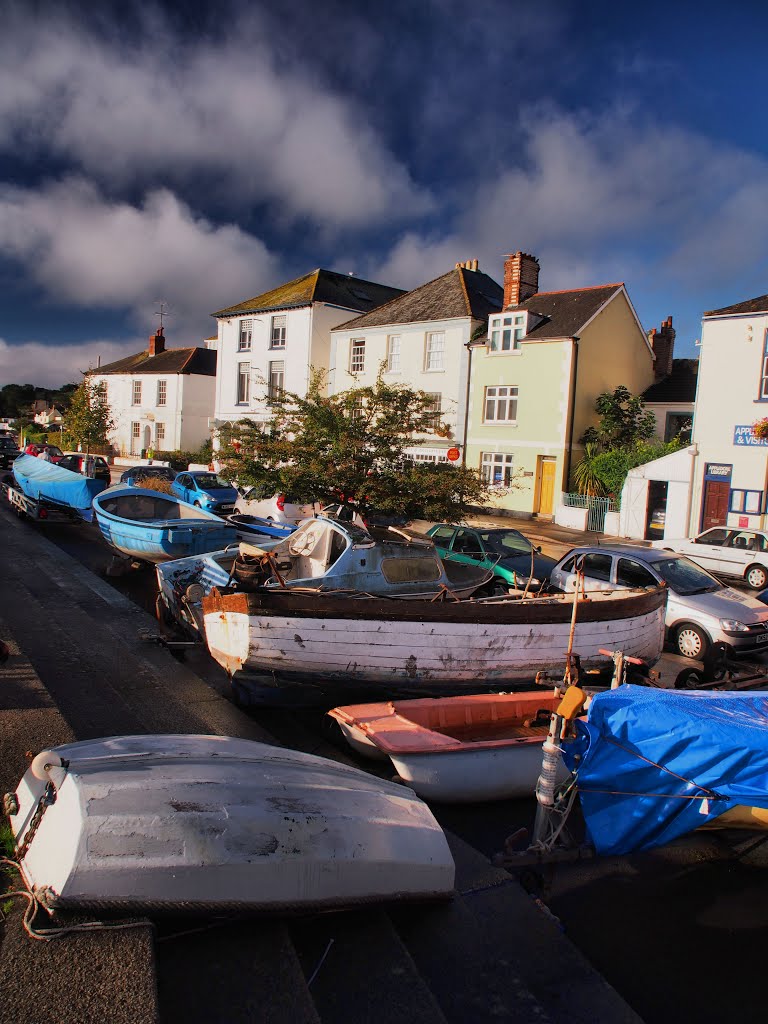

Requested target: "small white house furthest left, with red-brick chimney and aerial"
[{"left": 88, "top": 327, "right": 217, "bottom": 456}]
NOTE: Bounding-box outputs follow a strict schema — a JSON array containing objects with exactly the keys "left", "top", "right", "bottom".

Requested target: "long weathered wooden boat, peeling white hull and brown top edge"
[{"left": 202, "top": 588, "right": 667, "bottom": 703}]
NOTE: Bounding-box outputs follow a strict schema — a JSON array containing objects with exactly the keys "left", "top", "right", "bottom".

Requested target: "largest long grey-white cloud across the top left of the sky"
[{"left": 0, "top": 8, "right": 429, "bottom": 226}]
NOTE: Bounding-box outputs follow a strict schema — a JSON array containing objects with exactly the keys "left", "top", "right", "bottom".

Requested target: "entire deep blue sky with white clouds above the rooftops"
[{"left": 0, "top": 0, "right": 768, "bottom": 387}]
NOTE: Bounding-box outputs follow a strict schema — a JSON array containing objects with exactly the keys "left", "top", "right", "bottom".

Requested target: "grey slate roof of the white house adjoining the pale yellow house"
[{"left": 334, "top": 266, "right": 504, "bottom": 331}]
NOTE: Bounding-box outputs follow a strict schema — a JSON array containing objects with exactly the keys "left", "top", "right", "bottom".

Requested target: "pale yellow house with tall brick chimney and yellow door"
[{"left": 466, "top": 252, "right": 654, "bottom": 516}]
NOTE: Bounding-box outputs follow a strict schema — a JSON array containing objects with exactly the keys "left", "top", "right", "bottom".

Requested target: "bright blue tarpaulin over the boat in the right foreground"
[{"left": 564, "top": 686, "right": 768, "bottom": 854}]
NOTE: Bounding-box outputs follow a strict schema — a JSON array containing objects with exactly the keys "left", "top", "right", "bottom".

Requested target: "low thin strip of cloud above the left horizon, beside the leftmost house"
[{"left": 0, "top": 337, "right": 140, "bottom": 388}]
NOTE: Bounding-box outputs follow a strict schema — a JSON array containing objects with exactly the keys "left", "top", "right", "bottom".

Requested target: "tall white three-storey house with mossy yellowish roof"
[{"left": 206, "top": 269, "right": 402, "bottom": 427}]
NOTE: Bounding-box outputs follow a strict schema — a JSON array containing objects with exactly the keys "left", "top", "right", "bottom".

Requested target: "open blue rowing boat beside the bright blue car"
[{"left": 93, "top": 485, "right": 238, "bottom": 562}]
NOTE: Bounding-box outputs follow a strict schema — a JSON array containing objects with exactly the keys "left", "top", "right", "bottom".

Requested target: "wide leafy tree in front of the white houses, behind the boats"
[{"left": 219, "top": 371, "right": 488, "bottom": 521}]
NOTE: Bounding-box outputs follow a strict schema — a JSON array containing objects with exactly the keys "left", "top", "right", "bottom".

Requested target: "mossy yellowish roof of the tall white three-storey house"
[{"left": 211, "top": 269, "right": 402, "bottom": 317}]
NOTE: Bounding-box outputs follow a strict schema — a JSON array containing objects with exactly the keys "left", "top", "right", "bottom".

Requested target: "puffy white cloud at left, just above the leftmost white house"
[{"left": 0, "top": 178, "right": 275, "bottom": 333}]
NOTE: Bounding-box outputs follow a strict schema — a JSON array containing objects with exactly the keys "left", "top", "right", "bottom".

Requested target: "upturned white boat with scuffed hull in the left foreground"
[{"left": 10, "top": 735, "right": 454, "bottom": 911}]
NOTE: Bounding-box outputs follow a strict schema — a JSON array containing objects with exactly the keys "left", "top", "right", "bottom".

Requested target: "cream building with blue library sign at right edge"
[{"left": 689, "top": 295, "right": 768, "bottom": 536}]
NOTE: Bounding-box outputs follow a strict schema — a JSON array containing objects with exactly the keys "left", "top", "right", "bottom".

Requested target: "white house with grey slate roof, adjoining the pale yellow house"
[{"left": 330, "top": 260, "right": 503, "bottom": 462}]
